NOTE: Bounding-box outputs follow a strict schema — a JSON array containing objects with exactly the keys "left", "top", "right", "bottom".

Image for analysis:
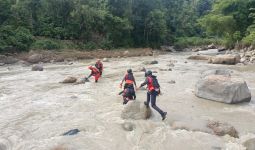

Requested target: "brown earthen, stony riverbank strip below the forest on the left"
[{"left": 0, "top": 48, "right": 154, "bottom": 66}]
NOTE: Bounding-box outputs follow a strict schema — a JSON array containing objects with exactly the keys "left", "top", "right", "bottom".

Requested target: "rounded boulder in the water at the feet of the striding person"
[{"left": 121, "top": 100, "right": 151, "bottom": 120}]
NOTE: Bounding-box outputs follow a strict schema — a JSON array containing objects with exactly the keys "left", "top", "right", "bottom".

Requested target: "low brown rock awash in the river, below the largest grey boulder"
[{"left": 207, "top": 121, "right": 239, "bottom": 138}]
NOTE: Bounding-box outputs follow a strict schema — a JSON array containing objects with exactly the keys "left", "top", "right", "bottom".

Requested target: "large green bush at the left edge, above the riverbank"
[{"left": 0, "top": 26, "right": 34, "bottom": 52}]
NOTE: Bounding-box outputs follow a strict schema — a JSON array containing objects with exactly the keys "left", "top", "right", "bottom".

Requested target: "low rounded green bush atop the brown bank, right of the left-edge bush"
[{"left": 32, "top": 39, "right": 62, "bottom": 50}]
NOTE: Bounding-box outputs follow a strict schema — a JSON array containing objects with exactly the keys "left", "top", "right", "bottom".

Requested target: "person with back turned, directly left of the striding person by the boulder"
[{"left": 120, "top": 69, "right": 136, "bottom": 99}]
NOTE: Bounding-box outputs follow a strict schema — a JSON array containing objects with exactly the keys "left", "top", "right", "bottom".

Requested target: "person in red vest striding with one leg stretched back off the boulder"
[{"left": 138, "top": 70, "right": 167, "bottom": 120}]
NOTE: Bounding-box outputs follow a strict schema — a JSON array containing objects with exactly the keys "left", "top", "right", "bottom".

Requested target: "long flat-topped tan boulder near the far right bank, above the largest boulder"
[{"left": 209, "top": 55, "right": 241, "bottom": 65}]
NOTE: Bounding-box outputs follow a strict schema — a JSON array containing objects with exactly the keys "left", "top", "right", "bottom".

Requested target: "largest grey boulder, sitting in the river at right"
[{"left": 195, "top": 70, "right": 251, "bottom": 104}]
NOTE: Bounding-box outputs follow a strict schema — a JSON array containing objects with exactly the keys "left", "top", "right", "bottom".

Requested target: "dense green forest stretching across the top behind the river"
[{"left": 0, "top": 0, "right": 255, "bottom": 52}]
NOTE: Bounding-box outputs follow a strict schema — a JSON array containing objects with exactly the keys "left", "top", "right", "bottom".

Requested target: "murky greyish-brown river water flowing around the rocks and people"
[{"left": 0, "top": 53, "right": 255, "bottom": 150}]
